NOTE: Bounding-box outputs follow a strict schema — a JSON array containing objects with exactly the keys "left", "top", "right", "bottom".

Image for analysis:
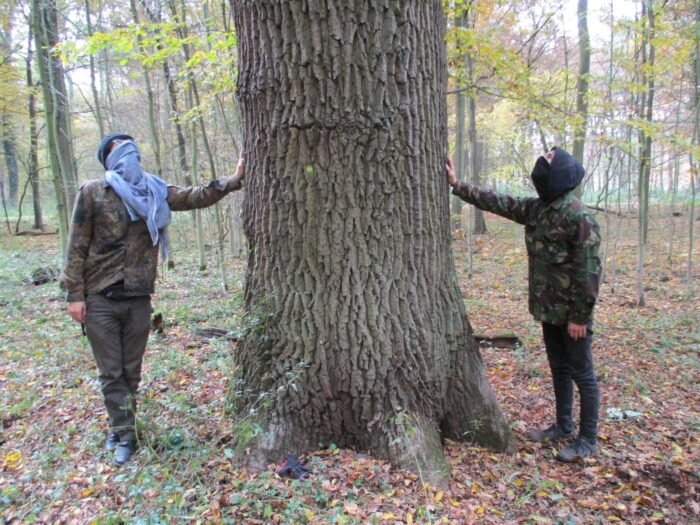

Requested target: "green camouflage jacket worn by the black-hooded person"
[{"left": 452, "top": 182, "right": 600, "bottom": 325}]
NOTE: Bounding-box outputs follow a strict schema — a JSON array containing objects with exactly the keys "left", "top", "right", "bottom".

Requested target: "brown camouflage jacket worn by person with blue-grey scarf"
[{"left": 61, "top": 177, "right": 241, "bottom": 302}]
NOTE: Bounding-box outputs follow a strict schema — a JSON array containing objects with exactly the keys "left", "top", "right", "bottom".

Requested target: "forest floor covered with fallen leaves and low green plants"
[{"left": 0, "top": 210, "right": 700, "bottom": 524}]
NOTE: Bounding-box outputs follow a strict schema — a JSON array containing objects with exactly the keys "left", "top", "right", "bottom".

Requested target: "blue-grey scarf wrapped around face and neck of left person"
[{"left": 105, "top": 140, "right": 170, "bottom": 259}]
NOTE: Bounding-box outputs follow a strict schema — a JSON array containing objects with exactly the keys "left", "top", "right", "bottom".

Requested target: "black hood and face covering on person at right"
[{"left": 532, "top": 148, "right": 586, "bottom": 202}]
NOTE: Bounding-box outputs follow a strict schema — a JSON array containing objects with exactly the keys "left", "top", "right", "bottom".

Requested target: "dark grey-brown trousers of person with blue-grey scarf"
[{"left": 85, "top": 294, "right": 151, "bottom": 440}]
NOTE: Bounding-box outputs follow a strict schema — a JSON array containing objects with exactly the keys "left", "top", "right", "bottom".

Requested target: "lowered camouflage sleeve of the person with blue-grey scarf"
[{"left": 61, "top": 187, "right": 94, "bottom": 303}]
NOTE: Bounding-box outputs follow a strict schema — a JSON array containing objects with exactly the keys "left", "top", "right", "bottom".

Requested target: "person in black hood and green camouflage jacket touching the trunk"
[{"left": 446, "top": 148, "right": 600, "bottom": 462}]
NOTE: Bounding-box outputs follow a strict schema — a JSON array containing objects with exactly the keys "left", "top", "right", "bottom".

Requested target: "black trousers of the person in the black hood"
[{"left": 542, "top": 323, "right": 600, "bottom": 443}]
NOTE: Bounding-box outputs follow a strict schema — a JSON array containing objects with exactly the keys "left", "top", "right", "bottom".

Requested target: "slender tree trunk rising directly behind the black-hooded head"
[{"left": 572, "top": 0, "right": 591, "bottom": 197}]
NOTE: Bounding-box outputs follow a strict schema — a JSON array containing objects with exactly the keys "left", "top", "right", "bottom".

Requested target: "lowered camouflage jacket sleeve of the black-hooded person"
[{"left": 569, "top": 213, "right": 601, "bottom": 324}]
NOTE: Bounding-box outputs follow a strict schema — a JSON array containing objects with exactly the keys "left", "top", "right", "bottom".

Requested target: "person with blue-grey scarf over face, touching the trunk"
[{"left": 61, "top": 133, "right": 245, "bottom": 465}]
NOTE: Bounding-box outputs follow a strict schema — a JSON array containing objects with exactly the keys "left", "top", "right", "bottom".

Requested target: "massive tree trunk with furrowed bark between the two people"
[{"left": 231, "top": 0, "right": 512, "bottom": 482}]
